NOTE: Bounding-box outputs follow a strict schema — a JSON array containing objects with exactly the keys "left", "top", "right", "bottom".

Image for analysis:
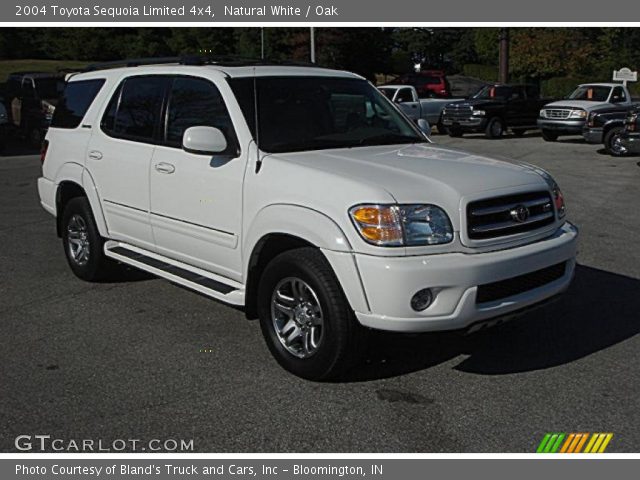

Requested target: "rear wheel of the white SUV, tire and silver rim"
[{"left": 62, "top": 197, "right": 116, "bottom": 282}]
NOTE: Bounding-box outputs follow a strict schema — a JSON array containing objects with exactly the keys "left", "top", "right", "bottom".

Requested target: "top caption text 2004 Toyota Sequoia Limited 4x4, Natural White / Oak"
[{"left": 15, "top": 3, "right": 340, "bottom": 20}]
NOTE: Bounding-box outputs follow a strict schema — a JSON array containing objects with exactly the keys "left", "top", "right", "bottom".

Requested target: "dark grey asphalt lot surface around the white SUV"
[{"left": 0, "top": 132, "right": 640, "bottom": 452}]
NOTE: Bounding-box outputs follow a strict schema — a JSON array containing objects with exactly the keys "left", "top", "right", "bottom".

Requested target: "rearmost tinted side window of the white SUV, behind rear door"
[{"left": 51, "top": 79, "right": 104, "bottom": 128}]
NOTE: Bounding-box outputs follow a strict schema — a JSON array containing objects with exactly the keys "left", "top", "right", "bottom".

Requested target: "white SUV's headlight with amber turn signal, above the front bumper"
[{"left": 349, "top": 205, "right": 453, "bottom": 247}]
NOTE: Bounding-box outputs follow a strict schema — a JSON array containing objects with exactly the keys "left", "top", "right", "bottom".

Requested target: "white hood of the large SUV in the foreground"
[{"left": 266, "top": 144, "right": 547, "bottom": 204}]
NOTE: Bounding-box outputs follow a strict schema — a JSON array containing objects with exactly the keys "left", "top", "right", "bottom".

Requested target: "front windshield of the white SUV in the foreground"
[{"left": 229, "top": 77, "right": 427, "bottom": 153}]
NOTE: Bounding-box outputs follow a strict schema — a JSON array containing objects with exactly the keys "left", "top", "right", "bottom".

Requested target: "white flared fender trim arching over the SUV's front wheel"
[{"left": 243, "top": 204, "right": 369, "bottom": 311}]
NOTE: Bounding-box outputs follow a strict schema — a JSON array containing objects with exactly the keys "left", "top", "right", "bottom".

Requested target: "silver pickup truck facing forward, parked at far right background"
[{"left": 538, "top": 83, "right": 632, "bottom": 142}]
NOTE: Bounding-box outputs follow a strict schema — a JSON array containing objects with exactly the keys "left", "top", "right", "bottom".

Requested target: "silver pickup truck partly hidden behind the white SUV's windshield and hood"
[{"left": 378, "top": 85, "right": 464, "bottom": 133}]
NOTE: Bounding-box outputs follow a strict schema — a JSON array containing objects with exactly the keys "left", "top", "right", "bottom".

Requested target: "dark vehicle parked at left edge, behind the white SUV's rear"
[{"left": 4, "top": 72, "right": 64, "bottom": 147}]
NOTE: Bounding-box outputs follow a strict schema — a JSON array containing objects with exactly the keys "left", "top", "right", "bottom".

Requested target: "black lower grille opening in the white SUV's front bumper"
[{"left": 476, "top": 262, "right": 566, "bottom": 303}]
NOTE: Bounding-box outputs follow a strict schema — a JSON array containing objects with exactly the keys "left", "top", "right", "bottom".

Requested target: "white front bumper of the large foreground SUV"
[{"left": 355, "top": 222, "right": 578, "bottom": 332}]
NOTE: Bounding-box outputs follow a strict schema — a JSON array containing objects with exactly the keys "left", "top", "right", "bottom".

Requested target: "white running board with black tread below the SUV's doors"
[{"left": 104, "top": 240, "right": 244, "bottom": 305}]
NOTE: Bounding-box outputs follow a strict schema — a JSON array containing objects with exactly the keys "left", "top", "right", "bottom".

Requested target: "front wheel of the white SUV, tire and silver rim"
[{"left": 258, "top": 247, "right": 364, "bottom": 381}]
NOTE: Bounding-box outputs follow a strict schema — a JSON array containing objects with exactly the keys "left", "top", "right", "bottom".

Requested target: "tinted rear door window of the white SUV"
[{"left": 101, "top": 76, "right": 168, "bottom": 142}]
